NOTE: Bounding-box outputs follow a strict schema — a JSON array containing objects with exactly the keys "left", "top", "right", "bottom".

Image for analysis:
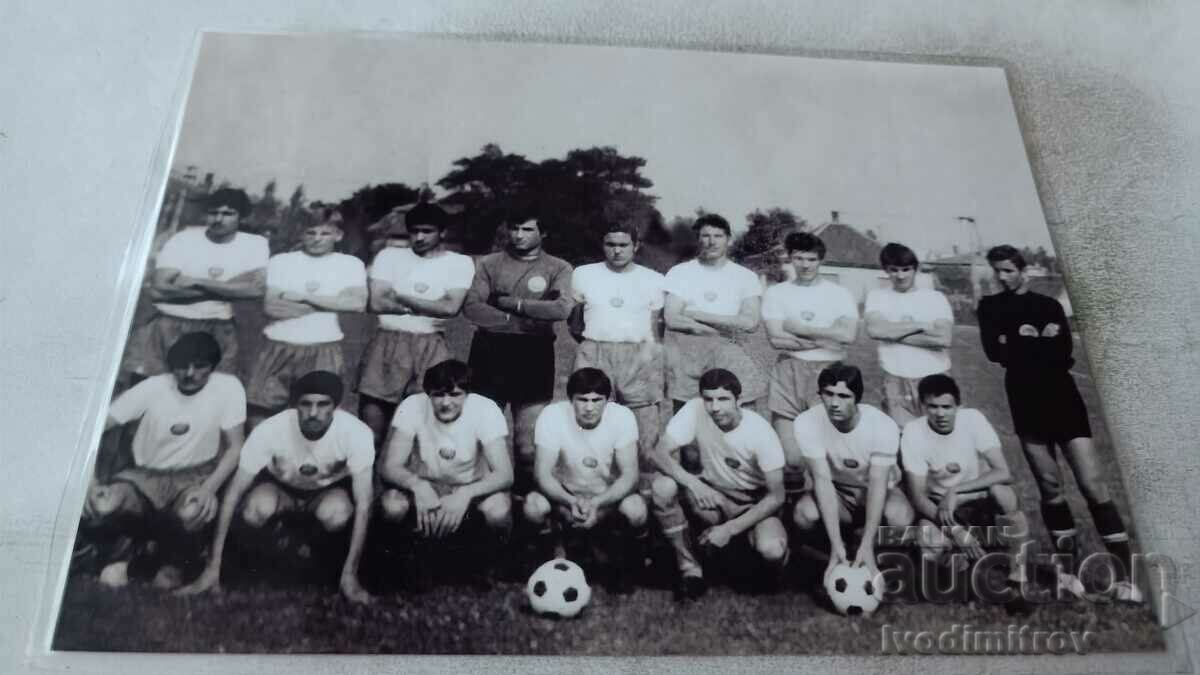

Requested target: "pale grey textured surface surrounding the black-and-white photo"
[{"left": 0, "top": 0, "right": 1200, "bottom": 673}]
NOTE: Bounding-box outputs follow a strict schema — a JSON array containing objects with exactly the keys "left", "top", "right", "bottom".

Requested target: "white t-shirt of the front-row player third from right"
[{"left": 665, "top": 399, "right": 786, "bottom": 492}]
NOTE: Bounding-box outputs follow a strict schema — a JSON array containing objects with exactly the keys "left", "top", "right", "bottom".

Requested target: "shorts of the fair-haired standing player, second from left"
[{"left": 246, "top": 339, "right": 346, "bottom": 411}]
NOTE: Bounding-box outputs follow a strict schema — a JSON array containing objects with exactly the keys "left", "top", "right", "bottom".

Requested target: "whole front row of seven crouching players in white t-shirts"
[{"left": 83, "top": 333, "right": 1078, "bottom": 602}]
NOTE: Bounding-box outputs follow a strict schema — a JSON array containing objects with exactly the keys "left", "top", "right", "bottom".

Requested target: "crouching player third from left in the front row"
[{"left": 380, "top": 360, "right": 512, "bottom": 583}]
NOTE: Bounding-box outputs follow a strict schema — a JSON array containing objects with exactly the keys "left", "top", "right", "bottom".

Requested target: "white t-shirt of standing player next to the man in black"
[{"left": 863, "top": 287, "right": 954, "bottom": 378}]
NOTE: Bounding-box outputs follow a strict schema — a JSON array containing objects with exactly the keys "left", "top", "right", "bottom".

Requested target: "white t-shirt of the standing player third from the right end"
[{"left": 762, "top": 279, "right": 858, "bottom": 362}]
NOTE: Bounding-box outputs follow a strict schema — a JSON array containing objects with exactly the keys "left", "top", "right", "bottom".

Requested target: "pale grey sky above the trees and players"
[{"left": 173, "top": 30, "right": 1051, "bottom": 256}]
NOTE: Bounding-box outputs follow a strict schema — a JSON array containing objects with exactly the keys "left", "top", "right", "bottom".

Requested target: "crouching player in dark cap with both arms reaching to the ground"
[{"left": 180, "top": 370, "right": 374, "bottom": 603}]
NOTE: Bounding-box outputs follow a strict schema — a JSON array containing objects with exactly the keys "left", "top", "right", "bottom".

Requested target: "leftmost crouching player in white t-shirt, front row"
[{"left": 83, "top": 333, "right": 246, "bottom": 587}]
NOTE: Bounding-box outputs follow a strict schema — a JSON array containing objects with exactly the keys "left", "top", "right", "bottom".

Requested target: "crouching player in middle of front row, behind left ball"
[{"left": 524, "top": 368, "right": 647, "bottom": 593}]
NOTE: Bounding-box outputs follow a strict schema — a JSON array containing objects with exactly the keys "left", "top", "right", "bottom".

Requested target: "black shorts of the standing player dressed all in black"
[{"left": 1004, "top": 370, "right": 1092, "bottom": 443}]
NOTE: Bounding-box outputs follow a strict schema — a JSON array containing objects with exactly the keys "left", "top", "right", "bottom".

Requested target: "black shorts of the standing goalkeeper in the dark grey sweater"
[{"left": 467, "top": 330, "right": 554, "bottom": 406}]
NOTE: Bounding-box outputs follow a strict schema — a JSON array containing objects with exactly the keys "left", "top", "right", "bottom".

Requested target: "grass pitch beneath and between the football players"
[{"left": 54, "top": 295, "right": 1164, "bottom": 656}]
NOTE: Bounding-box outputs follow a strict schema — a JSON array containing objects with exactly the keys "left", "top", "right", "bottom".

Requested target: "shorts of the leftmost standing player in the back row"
[{"left": 122, "top": 312, "right": 238, "bottom": 377}]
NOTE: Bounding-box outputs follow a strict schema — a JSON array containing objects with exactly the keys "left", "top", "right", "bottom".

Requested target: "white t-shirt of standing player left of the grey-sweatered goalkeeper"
[{"left": 370, "top": 247, "right": 475, "bottom": 333}]
